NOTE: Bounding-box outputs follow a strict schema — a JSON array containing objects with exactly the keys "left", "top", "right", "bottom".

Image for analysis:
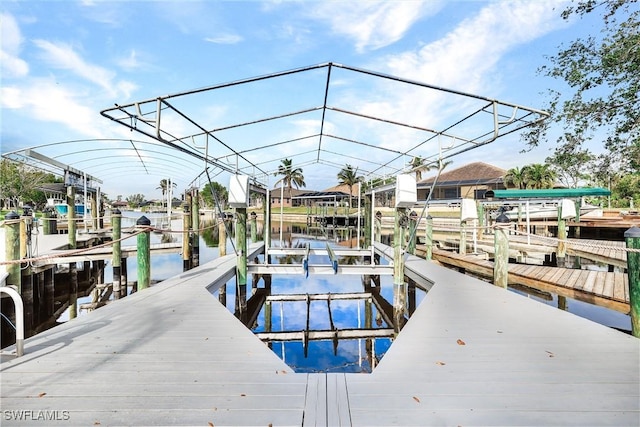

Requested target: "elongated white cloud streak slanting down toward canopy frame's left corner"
[{"left": 34, "top": 39, "right": 136, "bottom": 97}]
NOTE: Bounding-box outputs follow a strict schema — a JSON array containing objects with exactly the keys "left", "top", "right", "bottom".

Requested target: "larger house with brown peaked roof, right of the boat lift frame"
[{"left": 417, "top": 162, "right": 507, "bottom": 200}]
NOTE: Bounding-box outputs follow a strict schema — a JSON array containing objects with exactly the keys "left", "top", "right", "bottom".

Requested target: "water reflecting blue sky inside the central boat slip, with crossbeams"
[{"left": 214, "top": 233, "right": 425, "bottom": 372}]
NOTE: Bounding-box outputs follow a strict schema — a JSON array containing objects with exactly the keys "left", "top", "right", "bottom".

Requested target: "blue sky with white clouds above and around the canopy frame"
[{"left": 0, "top": 0, "right": 599, "bottom": 199}]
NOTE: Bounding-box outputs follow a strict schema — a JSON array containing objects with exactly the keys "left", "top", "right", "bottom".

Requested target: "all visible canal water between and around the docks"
[{"left": 60, "top": 212, "right": 631, "bottom": 372}]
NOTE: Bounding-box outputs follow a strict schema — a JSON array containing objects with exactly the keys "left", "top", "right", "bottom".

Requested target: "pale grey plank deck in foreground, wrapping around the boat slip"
[{"left": 0, "top": 244, "right": 640, "bottom": 426}]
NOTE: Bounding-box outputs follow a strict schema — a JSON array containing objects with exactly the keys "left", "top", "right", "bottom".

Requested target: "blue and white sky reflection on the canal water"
[{"left": 59, "top": 217, "right": 631, "bottom": 372}]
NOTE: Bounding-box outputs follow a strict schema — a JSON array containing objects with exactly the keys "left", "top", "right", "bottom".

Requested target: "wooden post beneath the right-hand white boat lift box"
[{"left": 393, "top": 207, "right": 408, "bottom": 336}]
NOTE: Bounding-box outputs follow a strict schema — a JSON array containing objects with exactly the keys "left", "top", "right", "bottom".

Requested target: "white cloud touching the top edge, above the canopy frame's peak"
[{"left": 305, "top": 1, "right": 442, "bottom": 52}]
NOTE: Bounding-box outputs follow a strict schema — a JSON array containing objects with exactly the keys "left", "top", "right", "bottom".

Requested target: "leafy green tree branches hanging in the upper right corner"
[{"left": 524, "top": 0, "right": 640, "bottom": 173}]
